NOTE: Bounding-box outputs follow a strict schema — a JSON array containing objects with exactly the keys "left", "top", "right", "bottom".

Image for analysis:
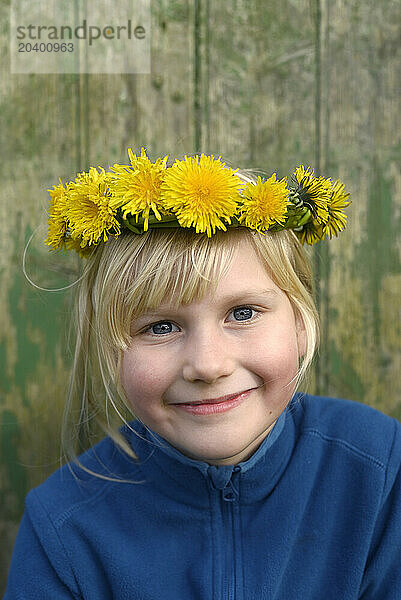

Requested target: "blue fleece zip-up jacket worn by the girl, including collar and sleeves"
[{"left": 5, "top": 394, "right": 401, "bottom": 600}]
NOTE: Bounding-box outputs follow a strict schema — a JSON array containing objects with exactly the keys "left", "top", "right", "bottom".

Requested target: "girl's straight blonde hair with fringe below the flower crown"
[{"left": 62, "top": 172, "right": 320, "bottom": 479}]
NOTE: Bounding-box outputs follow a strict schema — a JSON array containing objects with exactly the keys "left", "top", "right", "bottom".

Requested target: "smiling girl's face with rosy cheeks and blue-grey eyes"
[{"left": 121, "top": 240, "right": 305, "bottom": 465}]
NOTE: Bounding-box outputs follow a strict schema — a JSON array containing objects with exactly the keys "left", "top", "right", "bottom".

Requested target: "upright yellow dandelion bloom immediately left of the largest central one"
[{"left": 111, "top": 148, "right": 168, "bottom": 231}]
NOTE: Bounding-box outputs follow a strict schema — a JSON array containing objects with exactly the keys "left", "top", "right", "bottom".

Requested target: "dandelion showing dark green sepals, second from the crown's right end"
[{"left": 290, "top": 165, "right": 331, "bottom": 223}]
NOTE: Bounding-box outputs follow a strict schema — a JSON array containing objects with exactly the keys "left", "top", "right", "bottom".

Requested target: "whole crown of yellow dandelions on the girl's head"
[{"left": 45, "top": 148, "right": 350, "bottom": 257}]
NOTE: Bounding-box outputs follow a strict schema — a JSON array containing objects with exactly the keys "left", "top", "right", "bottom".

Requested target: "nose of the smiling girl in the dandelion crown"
[{"left": 183, "top": 333, "right": 235, "bottom": 383}]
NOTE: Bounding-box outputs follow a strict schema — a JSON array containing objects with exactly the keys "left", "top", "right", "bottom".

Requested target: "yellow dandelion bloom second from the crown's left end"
[{"left": 67, "top": 167, "right": 121, "bottom": 248}]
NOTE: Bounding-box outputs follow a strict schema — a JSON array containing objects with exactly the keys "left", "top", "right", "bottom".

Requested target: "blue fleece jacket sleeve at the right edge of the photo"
[{"left": 359, "top": 419, "right": 401, "bottom": 600}]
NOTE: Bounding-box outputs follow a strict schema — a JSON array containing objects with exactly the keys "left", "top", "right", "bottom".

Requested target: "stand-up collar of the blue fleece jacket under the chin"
[{"left": 125, "top": 395, "right": 296, "bottom": 508}]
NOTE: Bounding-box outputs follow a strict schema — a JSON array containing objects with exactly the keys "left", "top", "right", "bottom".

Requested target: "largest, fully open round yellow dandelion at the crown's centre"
[{"left": 162, "top": 154, "right": 244, "bottom": 237}]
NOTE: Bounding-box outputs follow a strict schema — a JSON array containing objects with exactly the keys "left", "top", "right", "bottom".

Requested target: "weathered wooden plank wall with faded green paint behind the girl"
[{"left": 0, "top": 0, "right": 401, "bottom": 592}]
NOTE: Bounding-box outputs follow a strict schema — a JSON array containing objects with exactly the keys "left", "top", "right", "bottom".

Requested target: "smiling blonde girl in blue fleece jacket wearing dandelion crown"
[{"left": 5, "top": 149, "right": 401, "bottom": 600}]
